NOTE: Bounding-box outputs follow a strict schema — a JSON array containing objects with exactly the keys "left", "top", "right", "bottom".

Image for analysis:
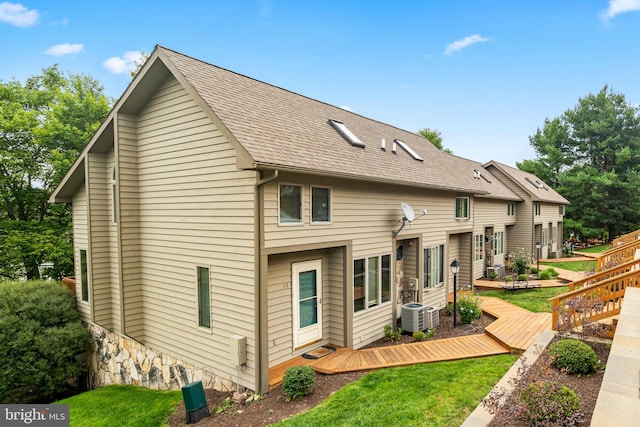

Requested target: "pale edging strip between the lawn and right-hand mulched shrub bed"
[{"left": 461, "top": 329, "right": 557, "bottom": 427}]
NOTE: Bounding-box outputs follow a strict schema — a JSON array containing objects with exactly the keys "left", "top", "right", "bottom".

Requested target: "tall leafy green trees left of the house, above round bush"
[{"left": 0, "top": 65, "right": 110, "bottom": 279}]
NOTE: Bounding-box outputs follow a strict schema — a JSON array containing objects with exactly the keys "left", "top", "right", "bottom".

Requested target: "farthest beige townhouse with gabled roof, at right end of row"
[{"left": 484, "top": 161, "right": 569, "bottom": 258}]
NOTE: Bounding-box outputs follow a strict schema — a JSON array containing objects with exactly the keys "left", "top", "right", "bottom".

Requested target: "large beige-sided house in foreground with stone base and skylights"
[{"left": 50, "top": 47, "right": 564, "bottom": 392}]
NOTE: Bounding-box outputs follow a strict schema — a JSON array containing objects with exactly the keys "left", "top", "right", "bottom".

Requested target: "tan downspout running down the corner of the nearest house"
[{"left": 255, "top": 169, "right": 280, "bottom": 393}]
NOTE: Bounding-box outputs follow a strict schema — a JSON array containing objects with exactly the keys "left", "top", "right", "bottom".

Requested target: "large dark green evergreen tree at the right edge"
[{"left": 518, "top": 85, "right": 640, "bottom": 239}]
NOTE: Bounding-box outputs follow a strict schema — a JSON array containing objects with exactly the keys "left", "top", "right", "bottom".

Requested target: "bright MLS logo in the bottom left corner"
[{"left": 0, "top": 405, "right": 69, "bottom": 427}]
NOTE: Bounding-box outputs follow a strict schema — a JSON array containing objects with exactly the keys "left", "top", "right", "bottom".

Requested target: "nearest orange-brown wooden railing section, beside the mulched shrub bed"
[{"left": 550, "top": 269, "right": 640, "bottom": 331}]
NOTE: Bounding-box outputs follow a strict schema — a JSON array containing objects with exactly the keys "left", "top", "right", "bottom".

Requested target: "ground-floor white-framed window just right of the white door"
[{"left": 353, "top": 255, "right": 391, "bottom": 312}]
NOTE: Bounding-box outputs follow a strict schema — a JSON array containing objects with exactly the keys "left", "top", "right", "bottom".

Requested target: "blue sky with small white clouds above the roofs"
[{"left": 0, "top": 0, "right": 640, "bottom": 166}]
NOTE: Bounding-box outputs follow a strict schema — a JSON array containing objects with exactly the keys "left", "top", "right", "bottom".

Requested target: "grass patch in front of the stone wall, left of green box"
[{"left": 56, "top": 385, "right": 182, "bottom": 427}]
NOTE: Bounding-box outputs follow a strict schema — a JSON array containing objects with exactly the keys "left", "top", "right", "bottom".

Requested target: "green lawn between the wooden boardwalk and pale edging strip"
[{"left": 276, "top": 354, "right": 517, "bottom": 427}]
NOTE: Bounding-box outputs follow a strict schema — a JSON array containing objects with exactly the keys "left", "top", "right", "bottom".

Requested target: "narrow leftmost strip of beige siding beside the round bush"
[{"left": 71, "top": 185, "right": 91, "bottom": 322}]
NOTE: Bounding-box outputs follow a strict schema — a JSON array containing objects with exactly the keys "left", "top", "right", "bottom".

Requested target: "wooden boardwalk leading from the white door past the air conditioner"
[{"left": 269, "top": 297, "right": 551, "bottom": 388}]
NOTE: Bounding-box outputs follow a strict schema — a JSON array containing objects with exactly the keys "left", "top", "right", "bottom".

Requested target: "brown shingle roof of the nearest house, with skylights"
[{"left": 158, "top": 47, "right": 519, "bottom": 200}]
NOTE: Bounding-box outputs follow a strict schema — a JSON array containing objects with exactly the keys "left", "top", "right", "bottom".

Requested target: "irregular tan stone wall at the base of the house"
[{"left": 88, "top": 324, "right": 235, "bottom": 391}]
